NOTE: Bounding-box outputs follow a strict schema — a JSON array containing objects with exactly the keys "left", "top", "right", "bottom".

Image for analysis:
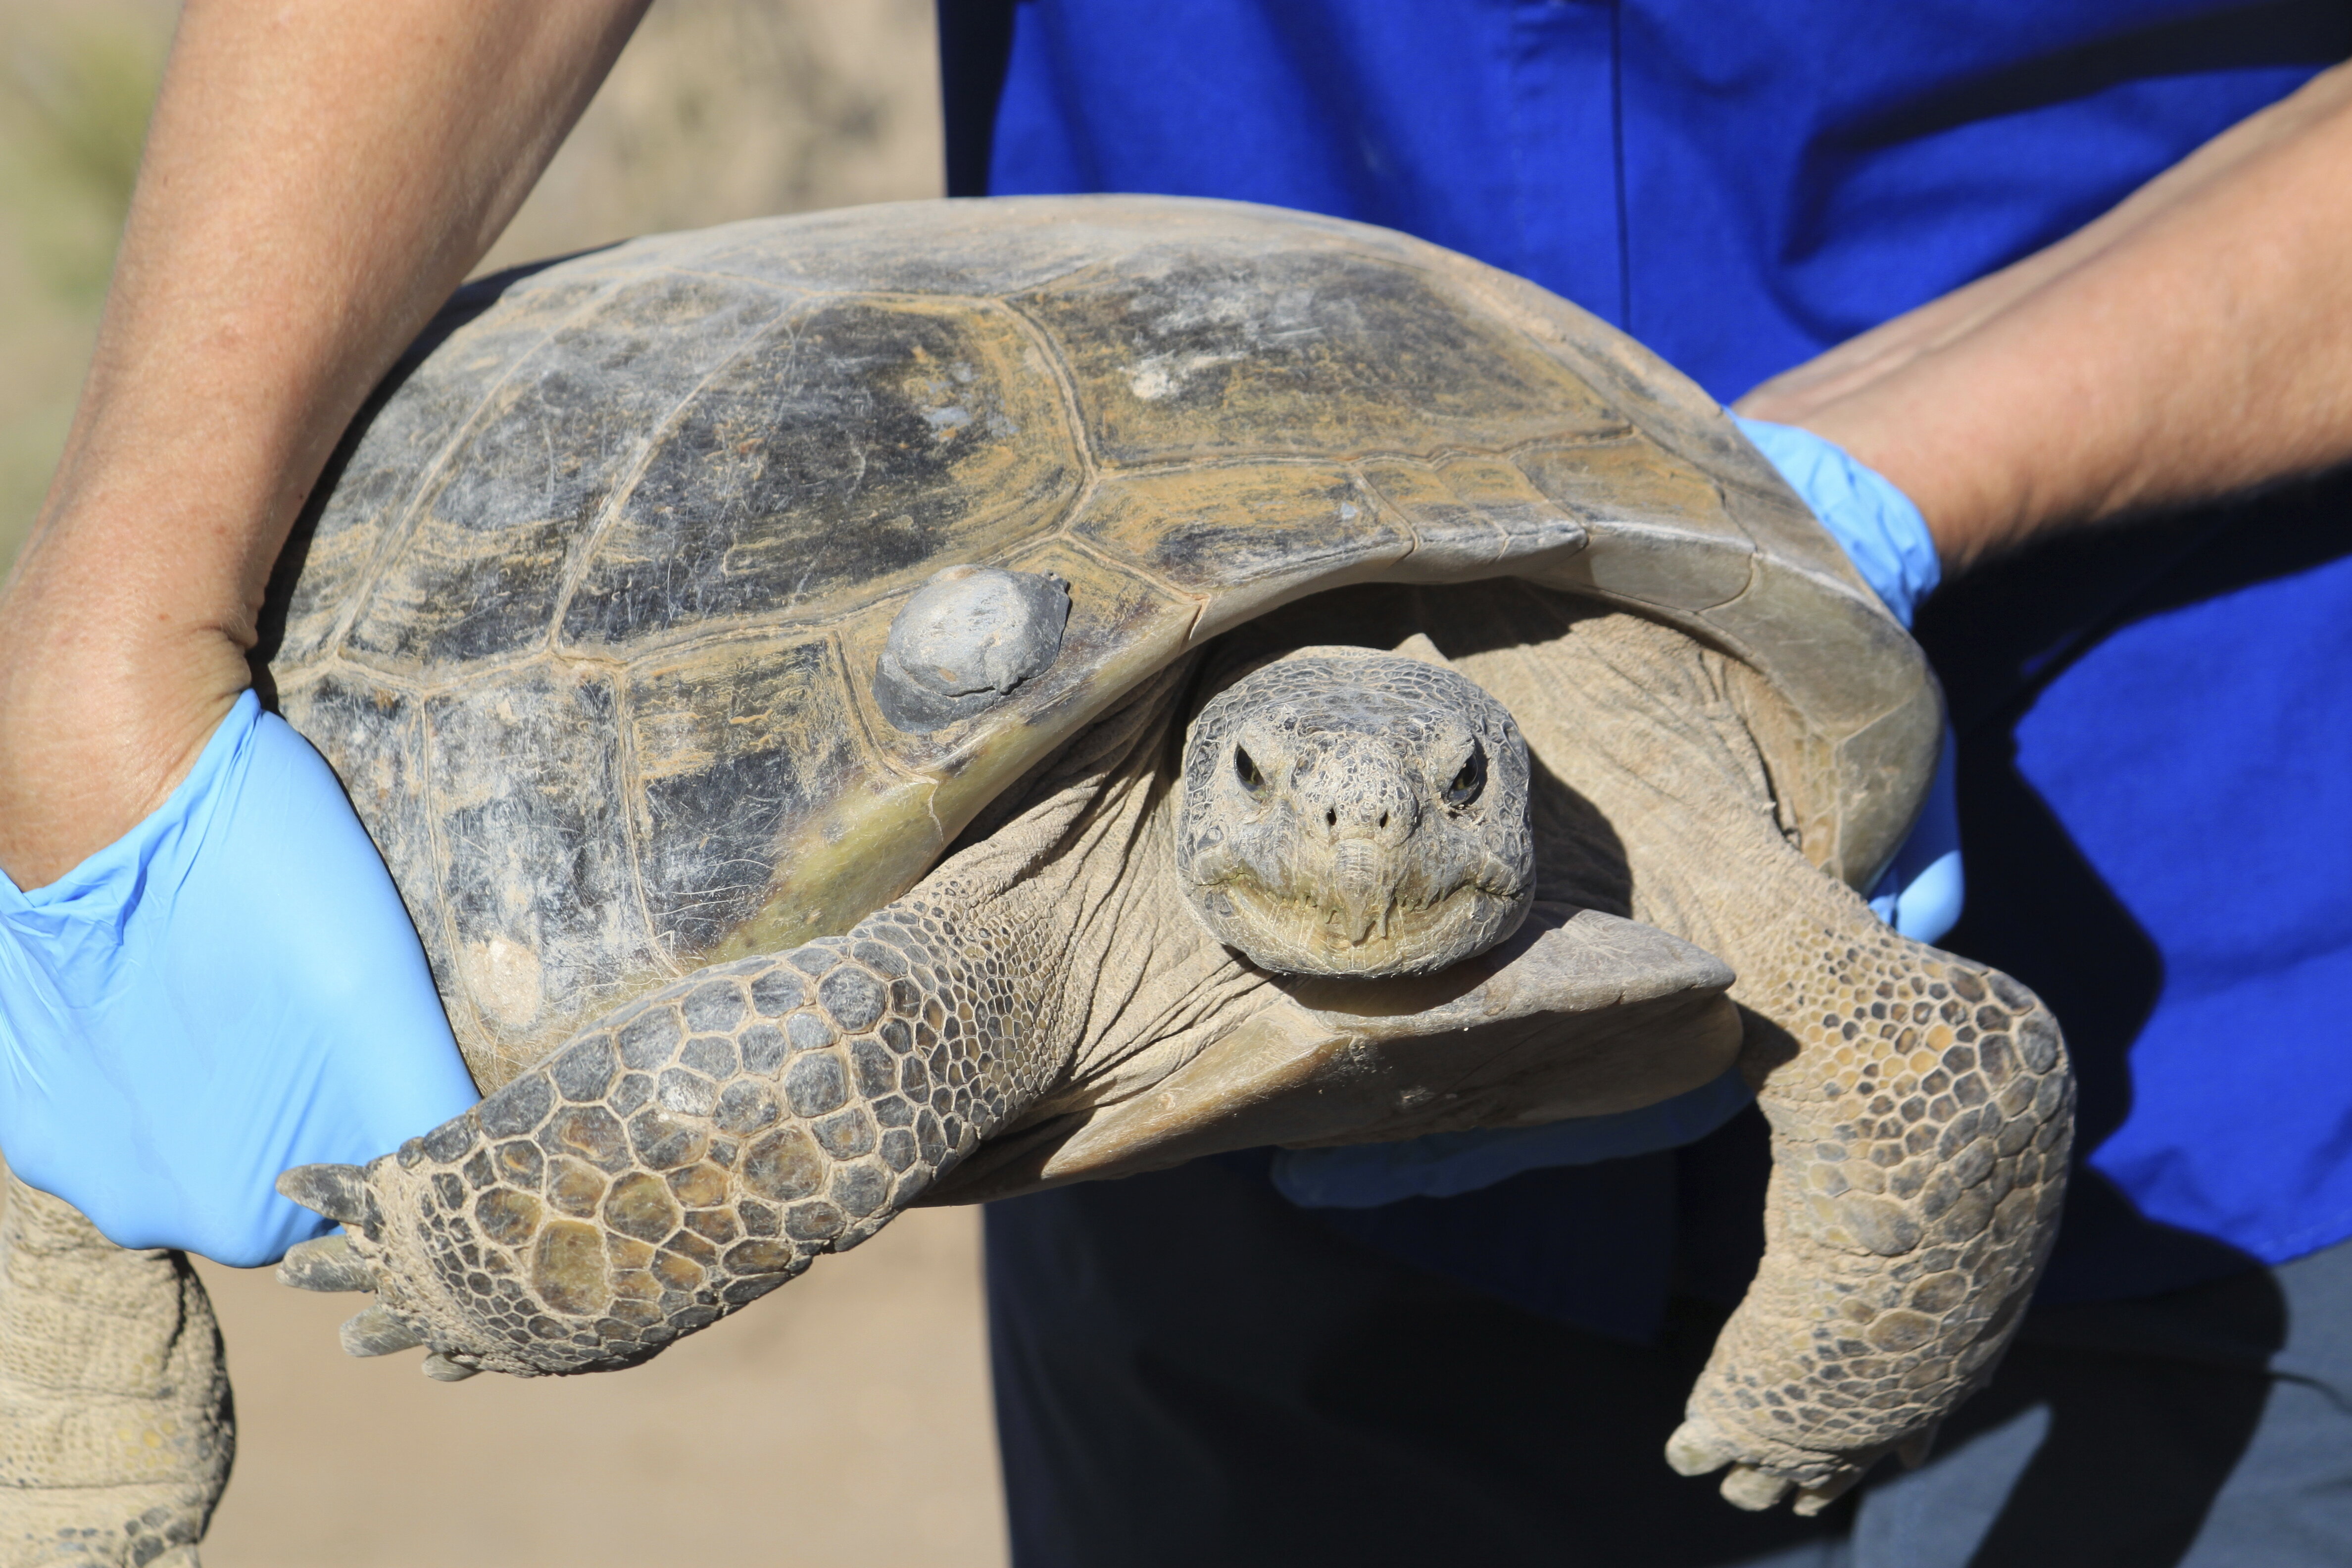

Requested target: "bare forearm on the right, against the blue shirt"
[{"left": 1740, "top": 70, "right": 2352, "bottom": 567}]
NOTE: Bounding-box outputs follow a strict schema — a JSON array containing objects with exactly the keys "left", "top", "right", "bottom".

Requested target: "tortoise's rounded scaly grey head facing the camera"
[{"left": 1176, "top": 646, "right": 1536, "bottom": 978}]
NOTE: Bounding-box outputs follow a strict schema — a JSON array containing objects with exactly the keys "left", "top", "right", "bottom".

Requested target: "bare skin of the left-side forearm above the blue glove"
[{"left": 0, "top": 0, "right": 647, "bottom": 886}]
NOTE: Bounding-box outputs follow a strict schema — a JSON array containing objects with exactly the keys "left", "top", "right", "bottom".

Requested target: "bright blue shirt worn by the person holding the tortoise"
[{"left": 941, "top": 0, "right": 2352, "bottom": 1333}]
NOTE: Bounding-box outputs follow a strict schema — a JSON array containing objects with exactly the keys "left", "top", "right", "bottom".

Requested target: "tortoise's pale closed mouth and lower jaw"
[{"left": 1185, "top": 875, "right": 1533, "bottom": 980}]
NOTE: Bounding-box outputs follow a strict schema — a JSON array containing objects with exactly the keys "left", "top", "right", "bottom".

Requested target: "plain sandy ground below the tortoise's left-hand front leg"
[{"left": 202, "top": 1208, "right": 1004, "bottom": 1568}]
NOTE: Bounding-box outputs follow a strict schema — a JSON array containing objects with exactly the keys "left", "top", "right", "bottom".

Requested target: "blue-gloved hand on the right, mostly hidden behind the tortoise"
[{"left": 1273, "top": 416, "right": 1961, "bottom": 1208}]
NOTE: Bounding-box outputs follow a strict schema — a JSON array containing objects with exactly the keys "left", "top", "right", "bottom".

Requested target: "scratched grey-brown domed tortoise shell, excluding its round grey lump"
[{"left": 270, "top": 197, "right": 1940, "bottom": 1086}]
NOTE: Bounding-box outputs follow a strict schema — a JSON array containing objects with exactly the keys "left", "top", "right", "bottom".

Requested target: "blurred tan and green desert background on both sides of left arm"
[{"left": 0, "top": 0, "right": 941, "bottom": 571}]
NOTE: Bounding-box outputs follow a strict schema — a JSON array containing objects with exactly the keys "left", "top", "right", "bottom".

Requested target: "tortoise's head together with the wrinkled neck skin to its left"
[{"left": 922, "top": 639, "right": 1536, "bottom": 1131}]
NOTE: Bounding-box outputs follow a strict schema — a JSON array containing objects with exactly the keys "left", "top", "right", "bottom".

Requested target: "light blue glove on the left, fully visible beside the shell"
[{"left": 0, "top": 691, "right": 478, "bottom": 1267}]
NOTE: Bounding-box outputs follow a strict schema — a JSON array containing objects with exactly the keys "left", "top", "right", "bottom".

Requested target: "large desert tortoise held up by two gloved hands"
[{"left": 0, "top": 197, "right": 2072, "bottom": 1561}]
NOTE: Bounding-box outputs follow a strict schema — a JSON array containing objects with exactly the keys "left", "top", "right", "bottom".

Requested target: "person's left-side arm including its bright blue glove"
[{"left": 0, "top": 0, "right": 642, "bottom": 1263}]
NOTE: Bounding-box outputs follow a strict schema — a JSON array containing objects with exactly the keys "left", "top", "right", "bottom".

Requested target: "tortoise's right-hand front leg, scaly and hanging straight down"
[{"left": 1665, "top": 912, "right": 2074, "bottom": 1514}]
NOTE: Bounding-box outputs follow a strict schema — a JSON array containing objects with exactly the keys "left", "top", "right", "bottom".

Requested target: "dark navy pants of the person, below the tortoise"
[{"left": 988, "top": 1161, "right": 2352, "bottom": 1568}]
